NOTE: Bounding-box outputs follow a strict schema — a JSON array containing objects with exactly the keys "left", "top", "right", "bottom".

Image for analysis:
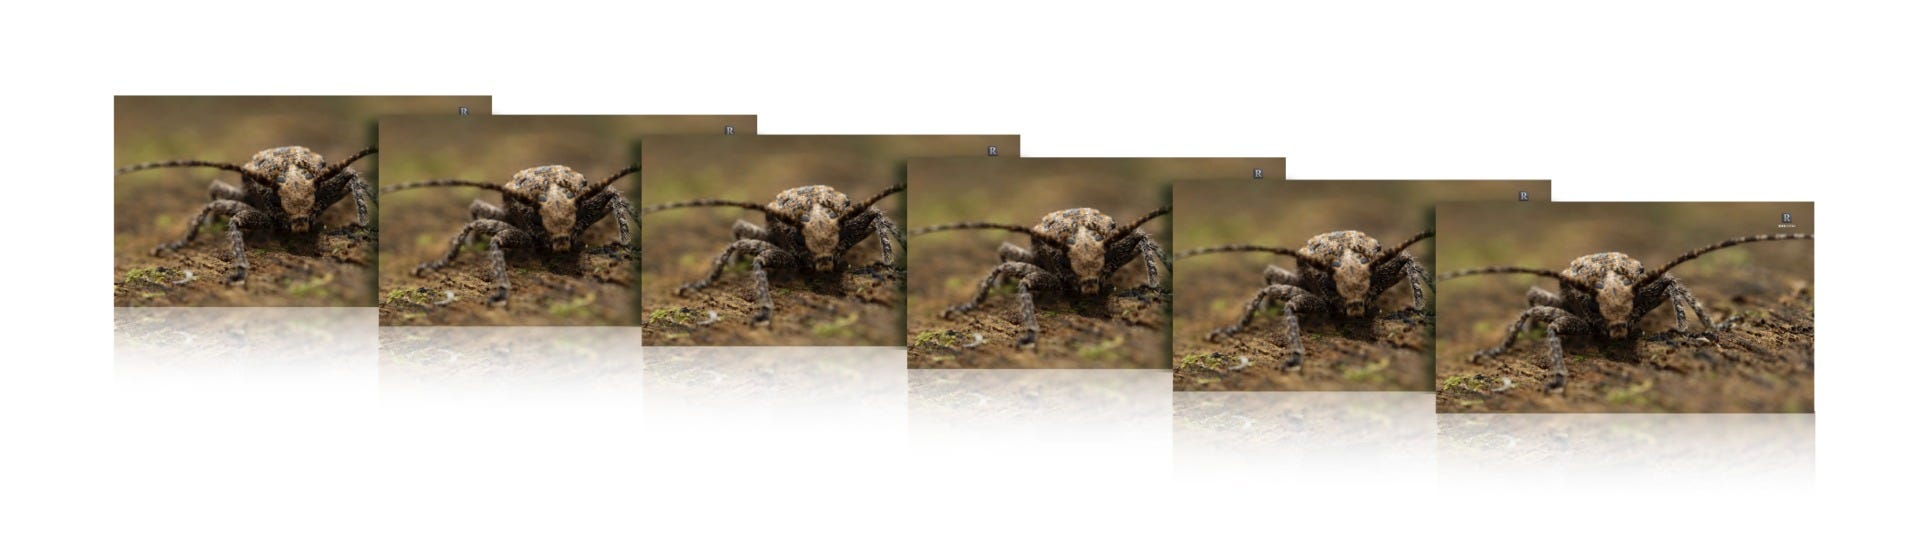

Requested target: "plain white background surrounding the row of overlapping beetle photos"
[{"left": 0, "top": 0, "right": 1919, "bottom": 536}]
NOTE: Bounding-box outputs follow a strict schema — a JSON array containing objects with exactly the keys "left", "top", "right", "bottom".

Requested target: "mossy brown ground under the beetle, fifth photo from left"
[{"left": 1173, "top": 269, "right": 1432, "bottom": 390}]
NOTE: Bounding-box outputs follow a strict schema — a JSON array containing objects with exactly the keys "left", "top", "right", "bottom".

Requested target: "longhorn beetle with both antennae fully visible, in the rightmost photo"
[{"left": 1439, "top": 234, "right": 1812, "bottom": 390}]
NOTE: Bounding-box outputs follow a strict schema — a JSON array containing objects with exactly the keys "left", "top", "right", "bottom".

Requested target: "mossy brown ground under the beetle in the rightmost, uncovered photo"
[{"left": 1437, "top": 267, "right": 1813, "bottom": 413}]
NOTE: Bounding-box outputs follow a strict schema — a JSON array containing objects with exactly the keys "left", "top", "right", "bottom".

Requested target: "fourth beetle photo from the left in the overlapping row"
[{"left": 906, "top": 158, "right": 1286, "bottom": 369}]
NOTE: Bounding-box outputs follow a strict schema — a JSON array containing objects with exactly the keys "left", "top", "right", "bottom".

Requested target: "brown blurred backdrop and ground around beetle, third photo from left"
[{"left": 639, "top": 135, "right": 1019, "bottom": 346}]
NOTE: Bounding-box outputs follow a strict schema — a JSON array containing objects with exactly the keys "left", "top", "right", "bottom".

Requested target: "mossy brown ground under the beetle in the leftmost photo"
[{"left": 113, "top": 177, "right": 374, "bottom": 306}]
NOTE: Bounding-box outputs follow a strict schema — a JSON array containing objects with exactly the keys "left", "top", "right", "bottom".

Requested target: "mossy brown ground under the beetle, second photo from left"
[{"left": 380, "top": 188, "right": 633, "bottom": 325}]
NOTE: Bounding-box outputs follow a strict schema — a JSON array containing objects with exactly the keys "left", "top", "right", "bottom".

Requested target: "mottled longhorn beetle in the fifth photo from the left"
[{"left": 1173, "top": 231, "right": 1433, "bottom": 369}]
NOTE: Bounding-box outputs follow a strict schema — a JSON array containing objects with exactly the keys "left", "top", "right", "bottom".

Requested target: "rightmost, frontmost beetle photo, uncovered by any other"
[{"left": 1435, "top": 202, "right": 1813, "bottom": 413}]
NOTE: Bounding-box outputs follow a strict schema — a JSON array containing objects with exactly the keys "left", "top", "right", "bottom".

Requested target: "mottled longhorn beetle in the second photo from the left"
[{"left": 380, "top": 165, "right": 639, "bottom": 304}]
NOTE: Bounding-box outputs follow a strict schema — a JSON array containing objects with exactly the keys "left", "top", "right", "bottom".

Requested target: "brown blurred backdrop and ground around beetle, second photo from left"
[{"left": 380, "top": 115, "right": 756, "bottom": 325}]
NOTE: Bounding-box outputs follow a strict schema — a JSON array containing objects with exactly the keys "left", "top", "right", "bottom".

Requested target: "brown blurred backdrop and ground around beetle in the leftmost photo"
[{"left": 113, "top": 96, "right": 493, "bottom": 306}]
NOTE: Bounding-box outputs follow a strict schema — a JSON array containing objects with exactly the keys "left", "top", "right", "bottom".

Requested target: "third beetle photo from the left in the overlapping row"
[{"left": 639, "top": 135, "right": 1019, "bottom": 348}]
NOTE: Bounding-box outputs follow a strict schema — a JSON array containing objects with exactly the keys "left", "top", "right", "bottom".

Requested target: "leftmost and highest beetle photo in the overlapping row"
[{"left": 113, "top": 96, "right": 493, "bottom": 306}]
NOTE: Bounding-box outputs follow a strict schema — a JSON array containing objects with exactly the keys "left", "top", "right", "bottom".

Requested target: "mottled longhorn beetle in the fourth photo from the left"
[{"left": 908, "top": 208, "right": 1173, "bottom": 348}]
